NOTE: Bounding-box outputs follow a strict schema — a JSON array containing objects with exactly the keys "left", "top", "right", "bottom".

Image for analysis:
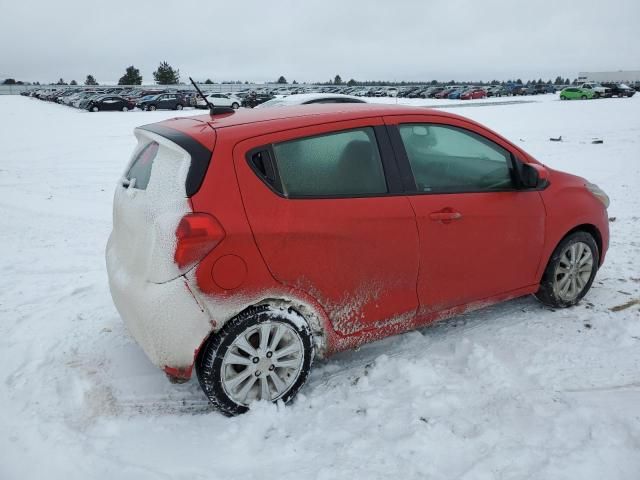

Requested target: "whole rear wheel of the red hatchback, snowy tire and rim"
[{"left": 196, "top": 305, "right": 313, "bottom": 415}]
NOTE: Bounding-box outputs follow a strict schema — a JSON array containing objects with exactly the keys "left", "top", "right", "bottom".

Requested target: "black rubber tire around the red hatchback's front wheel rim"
[{"left": 535, "top": 231, "right": 600, "bottom": 308}]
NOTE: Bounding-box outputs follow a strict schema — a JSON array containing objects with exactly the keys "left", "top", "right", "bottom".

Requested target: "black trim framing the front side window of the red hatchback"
[{"left": 388, "top": 121, "right": 541, "bottom": 196}]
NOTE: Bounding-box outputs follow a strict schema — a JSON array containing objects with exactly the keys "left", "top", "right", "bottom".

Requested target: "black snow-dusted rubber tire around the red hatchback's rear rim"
[{"left": 195, "top": 305, "right": 314, "bottom": 416}]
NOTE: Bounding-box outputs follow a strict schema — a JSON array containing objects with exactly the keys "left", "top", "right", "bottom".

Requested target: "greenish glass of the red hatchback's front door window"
[{"left": 399, "top": 124, "right": 513, "bottom": 192}]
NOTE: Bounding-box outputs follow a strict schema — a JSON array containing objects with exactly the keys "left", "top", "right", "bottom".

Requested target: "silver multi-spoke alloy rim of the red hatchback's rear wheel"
[{"left": 220, "top": 321, "right": 304, "bottom": 406}]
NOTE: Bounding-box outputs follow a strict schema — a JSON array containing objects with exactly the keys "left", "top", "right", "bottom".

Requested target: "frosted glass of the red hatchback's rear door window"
[{"left": 273, "top": 128, "right": 387, "bottom": 197}]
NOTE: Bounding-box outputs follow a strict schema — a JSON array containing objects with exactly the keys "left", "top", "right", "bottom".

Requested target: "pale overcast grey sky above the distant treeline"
[{"left": 0, "top": 0, "right": 640, "bottom": 83}]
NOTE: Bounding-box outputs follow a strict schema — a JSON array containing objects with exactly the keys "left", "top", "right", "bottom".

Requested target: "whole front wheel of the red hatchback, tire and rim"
[{"left": 535, "top": 232, "right": 600, "bottom": 308}]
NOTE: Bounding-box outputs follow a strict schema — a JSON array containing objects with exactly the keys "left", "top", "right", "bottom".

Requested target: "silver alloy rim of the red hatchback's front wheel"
[{"left": 553, "top": 242, "right": 593, "bottom": 301}]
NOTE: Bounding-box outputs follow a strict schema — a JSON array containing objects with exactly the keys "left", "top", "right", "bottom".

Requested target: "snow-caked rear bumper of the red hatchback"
[{"left": 107, "top": 239, "right": 211, "bottom": 369}]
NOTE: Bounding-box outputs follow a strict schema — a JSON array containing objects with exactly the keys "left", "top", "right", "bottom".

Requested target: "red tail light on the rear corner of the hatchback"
[{"left": 174, "top": 213, "right": 225, "bottom": 269}]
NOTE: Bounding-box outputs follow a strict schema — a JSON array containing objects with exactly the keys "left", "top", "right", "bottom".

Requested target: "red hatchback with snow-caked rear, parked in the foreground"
[{"left": 106, "top": 104, "right": 609, "bottom": 414}]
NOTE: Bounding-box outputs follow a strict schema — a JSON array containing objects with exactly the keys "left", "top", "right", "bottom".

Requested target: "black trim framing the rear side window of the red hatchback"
[{"left": 246, "top": 125, "right": 406, "bottom": 200}]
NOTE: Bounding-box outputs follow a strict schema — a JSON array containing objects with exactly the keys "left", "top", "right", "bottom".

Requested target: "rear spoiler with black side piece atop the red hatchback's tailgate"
[{"left": 138, "top": 123, "right": 215, "bottom": 197}]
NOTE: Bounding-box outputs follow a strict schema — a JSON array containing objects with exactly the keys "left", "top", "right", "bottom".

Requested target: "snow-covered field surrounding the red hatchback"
[{"left": 0, "top": 95, "right": 640, "bottom": 480}]
